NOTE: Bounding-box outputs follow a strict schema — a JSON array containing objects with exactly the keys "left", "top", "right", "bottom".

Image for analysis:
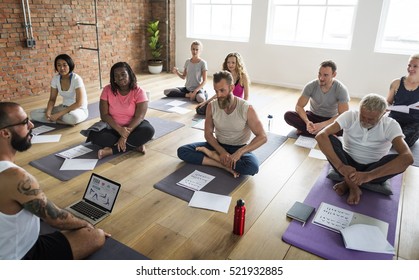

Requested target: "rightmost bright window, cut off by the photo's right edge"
[{"left": 375, "top": 0, "right": 419, "bottom": 54}]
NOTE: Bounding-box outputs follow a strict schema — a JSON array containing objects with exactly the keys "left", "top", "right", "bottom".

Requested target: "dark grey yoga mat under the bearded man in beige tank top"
[{"left": 154, "top": 133, "right": 287, "bottom": 202}]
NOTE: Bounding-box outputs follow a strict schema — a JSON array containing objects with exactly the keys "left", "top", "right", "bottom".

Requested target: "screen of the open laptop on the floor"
[{"left": 83, "top": 173, "right": 121, "bottom": 212}]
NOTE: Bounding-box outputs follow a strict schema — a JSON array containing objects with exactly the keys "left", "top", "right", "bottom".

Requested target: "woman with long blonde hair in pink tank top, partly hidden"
[{"left": 196, "top": 52, "right": 250, "bottom": 115}]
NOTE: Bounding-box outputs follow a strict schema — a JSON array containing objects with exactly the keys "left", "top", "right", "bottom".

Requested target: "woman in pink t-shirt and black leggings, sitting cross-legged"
[{"left": 87, "top": 62, "right": 154, "bottom": 159}]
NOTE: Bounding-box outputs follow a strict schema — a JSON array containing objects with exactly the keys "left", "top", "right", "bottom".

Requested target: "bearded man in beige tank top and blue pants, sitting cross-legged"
[{"left": 178, "top": 71, "right": 267, "bottom": 177}]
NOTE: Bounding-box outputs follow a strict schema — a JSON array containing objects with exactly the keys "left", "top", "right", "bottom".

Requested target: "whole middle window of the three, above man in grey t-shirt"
[{"left": 266, "top": 0, "right": 358, "bottom": 49}]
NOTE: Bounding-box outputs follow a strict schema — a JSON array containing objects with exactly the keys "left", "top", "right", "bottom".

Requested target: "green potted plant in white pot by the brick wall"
[{"left": 147, "top": 20, "right": 163, "bottom": 74}]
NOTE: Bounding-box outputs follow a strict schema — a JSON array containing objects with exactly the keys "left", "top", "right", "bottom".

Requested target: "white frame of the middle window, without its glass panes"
[{"left": 265, "top": 0, "right": 359, "bottom": 50}]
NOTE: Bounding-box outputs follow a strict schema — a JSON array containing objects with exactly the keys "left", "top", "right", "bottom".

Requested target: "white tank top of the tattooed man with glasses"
[{"left": 0, "top": 161, "right": 40, "bottom": 260}]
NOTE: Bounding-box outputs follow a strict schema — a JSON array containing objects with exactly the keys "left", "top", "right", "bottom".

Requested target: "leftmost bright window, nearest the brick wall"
[{"left": 187, "top": 0, "right": 252, "bottom": 42}]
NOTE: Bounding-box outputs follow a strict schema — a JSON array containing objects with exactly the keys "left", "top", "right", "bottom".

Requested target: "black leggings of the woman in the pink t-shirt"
[{"left": 86, "top": 120, "right": 154, "bottom": 154}]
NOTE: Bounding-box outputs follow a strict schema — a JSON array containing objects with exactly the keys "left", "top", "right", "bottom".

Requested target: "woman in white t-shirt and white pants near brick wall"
[{"left": 30, "top": 54, "right": 89, "bottom": 125}]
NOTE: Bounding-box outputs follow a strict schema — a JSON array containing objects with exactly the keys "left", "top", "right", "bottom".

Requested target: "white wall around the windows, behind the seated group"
[{"left": 176, "top": 0, "right": 409, "bottom": 97}]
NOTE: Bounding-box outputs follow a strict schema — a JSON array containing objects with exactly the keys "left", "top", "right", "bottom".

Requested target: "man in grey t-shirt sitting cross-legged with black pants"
[{"left": 284, "top": 60, "right": 350, "bottom": 136}]
